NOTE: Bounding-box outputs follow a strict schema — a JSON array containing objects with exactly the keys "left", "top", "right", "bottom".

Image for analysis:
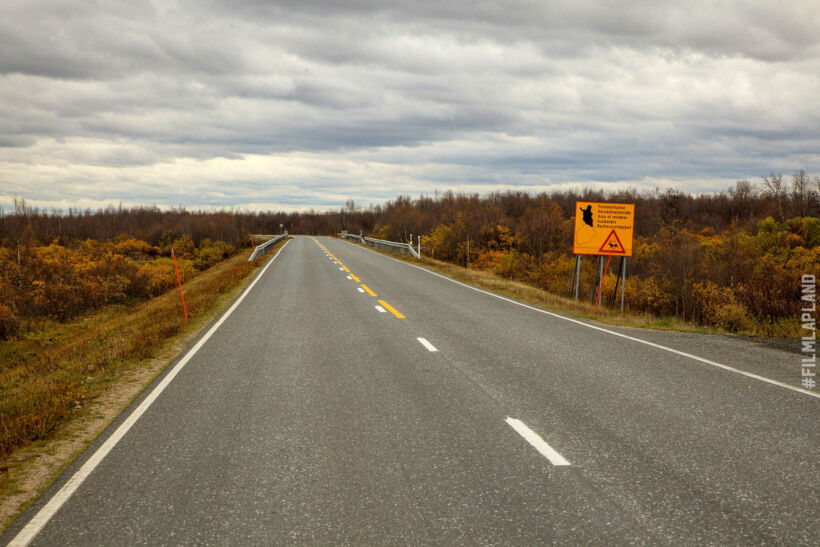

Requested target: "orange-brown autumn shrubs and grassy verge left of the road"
[{"left": 0, "top": 201, "right": 290, "bottom": 460}]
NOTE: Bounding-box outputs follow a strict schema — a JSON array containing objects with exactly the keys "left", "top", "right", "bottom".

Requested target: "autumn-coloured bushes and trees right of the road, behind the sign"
[{"left": 338, "top": 171, "right": 820, "bottom": 337}]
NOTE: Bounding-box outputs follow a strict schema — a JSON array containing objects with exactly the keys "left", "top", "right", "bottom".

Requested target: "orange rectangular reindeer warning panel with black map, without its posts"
[{"left": 572, "top": 201, "right": 635, "bottom": 256}]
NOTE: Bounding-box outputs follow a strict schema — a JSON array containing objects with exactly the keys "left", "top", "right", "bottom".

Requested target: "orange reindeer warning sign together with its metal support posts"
[{"left": 572, "top": 201, "right": 635, "bottom": 312}]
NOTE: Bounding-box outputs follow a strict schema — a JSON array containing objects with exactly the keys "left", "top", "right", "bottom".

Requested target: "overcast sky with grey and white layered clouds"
[{"left": 0, "top": 0, "right": 820, "bottom": 210}]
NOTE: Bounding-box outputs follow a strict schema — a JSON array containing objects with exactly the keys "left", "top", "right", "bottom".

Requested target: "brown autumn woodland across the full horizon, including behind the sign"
[{"left": 0, "top": 171, "right": 820, "bottom": 336}]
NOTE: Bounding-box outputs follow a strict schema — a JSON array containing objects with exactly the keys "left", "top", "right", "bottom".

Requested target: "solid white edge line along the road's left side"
[{"left": 8, "top": 240, "right": 292, "bottom": 547}]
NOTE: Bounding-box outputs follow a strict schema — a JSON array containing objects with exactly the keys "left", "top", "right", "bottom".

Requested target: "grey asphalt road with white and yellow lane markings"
[{"left": 0, "top": 237, "right": 820, "bottom": 545}]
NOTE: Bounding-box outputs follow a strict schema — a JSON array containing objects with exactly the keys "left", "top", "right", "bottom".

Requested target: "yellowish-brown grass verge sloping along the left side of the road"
[{"left": 0, "top": 242, "right": 282, "bottom": 460}]
